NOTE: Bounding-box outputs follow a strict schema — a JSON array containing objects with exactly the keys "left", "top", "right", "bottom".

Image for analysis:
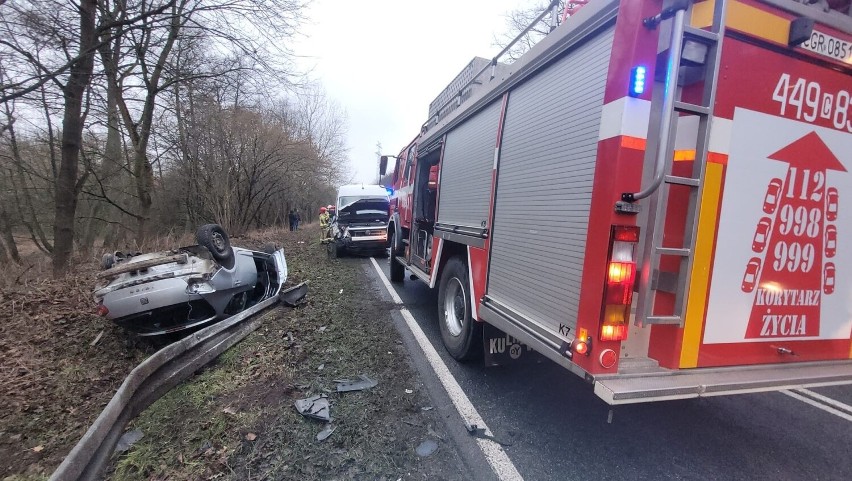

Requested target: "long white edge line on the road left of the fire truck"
[{"left": 370, "top": 257, "right": 524, "bottom": 481}]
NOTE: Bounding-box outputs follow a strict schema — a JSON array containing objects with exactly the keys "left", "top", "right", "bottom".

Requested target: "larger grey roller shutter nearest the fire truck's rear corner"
[{"left": 487, "top": 28, "right": 613, "bottom": 340}]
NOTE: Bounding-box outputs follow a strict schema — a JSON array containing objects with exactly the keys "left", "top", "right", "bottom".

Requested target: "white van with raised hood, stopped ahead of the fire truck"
[{"left": 328, "top": 184, "right": 390, "bottom": 257}]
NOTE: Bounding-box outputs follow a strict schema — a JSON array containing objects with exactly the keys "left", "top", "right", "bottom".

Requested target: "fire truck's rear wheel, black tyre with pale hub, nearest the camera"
[{"left": 438, "top": 257, "right": 482, "bottom": 361}]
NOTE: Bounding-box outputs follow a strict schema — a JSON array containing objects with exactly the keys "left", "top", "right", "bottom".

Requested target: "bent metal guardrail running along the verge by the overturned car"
[{"left": 50, "top": 283, "right": 306, "bottom": 481}]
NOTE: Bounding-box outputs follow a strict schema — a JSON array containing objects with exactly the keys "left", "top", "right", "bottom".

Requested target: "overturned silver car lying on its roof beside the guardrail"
[{"left": 94, "top": 224, "right": 287, "bottom": 336}]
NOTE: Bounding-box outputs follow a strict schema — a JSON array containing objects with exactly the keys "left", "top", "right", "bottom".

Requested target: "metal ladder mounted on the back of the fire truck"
[{"left": 622, "top": 0, "right": 727, "bottom": 326}]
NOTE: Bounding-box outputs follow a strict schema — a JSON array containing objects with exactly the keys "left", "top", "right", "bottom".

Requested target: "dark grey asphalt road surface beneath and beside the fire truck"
[{"left": 364, "top": 259, "right": 852, "bottom": 481}]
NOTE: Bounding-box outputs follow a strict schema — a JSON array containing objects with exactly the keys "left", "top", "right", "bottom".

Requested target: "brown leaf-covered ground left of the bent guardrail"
[{"left": 0, "top": 253, "right": 154, "bottom": 480}]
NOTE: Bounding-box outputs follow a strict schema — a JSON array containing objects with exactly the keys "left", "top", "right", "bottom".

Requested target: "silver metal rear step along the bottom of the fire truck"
[{"left": 595, "top": 361, "right": 852, "bottom": 405}]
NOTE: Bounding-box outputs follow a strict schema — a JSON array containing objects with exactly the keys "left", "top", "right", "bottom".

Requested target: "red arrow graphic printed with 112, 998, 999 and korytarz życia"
[{"left": 742, "top": 132, "right": 846, "bottom": 339}]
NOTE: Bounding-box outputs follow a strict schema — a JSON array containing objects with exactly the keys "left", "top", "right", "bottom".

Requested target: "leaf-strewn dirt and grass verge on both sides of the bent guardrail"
[{"left": 0, "top": 226, "right": 470, "bottom": 480}]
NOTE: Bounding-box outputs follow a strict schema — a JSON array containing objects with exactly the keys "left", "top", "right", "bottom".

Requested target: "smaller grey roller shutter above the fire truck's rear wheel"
[{"left": 438, "top": 101, "right": 501, "bottom": 229}]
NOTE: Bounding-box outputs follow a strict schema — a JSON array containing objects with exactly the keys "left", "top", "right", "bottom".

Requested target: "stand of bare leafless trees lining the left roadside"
[{"left": 0, "top": 0, "right": 347, "bottom": 274}]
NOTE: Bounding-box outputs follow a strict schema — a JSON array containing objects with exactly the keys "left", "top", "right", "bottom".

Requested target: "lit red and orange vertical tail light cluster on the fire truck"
[{"left": 599, "top": 226, "right": 639, "bottom": 341}]
